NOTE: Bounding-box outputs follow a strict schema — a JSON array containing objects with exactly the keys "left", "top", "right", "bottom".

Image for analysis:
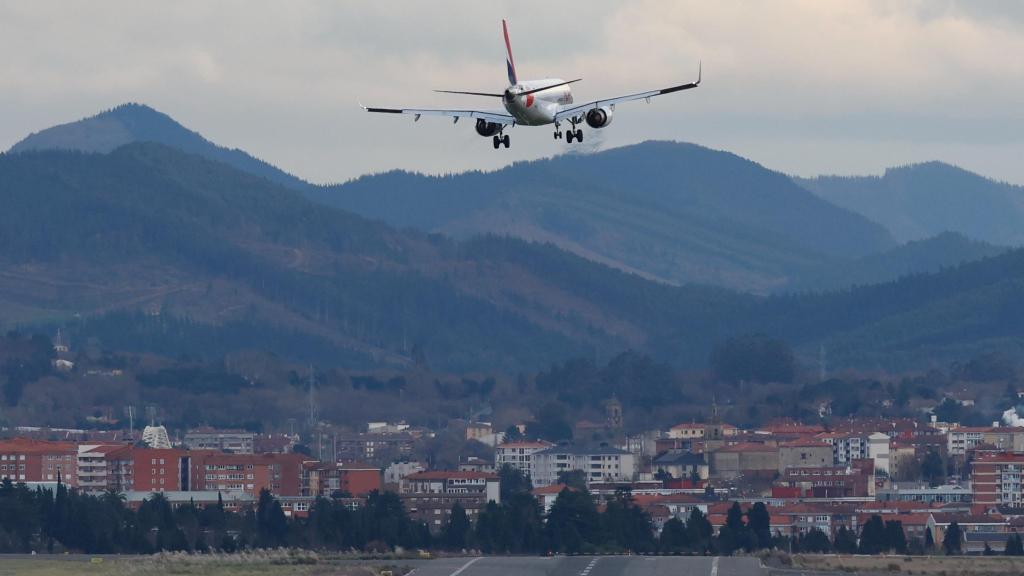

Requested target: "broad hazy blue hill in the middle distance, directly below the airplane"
[{"left": 309, "top": 141, "right": 895, "bottom": 292}]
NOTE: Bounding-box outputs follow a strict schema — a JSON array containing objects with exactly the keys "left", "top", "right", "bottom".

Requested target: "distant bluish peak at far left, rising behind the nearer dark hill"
[{"left": 10, "top": 104, "right": 310, "bottom": 190}]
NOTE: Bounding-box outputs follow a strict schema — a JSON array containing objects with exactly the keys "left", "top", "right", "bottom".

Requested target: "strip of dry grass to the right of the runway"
[{"left": 793, "top": 554, "right": 1024, "bottom": 576}]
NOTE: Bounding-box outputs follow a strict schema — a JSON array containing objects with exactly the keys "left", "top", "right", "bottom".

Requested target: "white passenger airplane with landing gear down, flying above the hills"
[{"left": 360, "top": 19, "right": 700, "bottom": 150}]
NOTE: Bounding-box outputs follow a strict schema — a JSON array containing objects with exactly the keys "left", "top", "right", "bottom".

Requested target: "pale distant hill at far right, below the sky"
[{"left": 797, "top": 162, "right": 1024, "bottom": 246}]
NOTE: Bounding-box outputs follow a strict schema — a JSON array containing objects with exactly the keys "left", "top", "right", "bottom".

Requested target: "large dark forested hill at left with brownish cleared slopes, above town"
[{"left": 0, "top": 143, "right": 753, "bottom": 370}]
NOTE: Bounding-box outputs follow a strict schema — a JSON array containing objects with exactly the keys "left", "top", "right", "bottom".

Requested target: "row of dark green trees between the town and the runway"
[{"left": 0, "top": 468, "right": 1024, "bottom": 556}]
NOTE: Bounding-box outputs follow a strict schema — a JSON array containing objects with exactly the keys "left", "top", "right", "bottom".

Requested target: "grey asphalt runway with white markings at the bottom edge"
[{"left": 403, "top": 556, "right": 767, "bottom": 576}]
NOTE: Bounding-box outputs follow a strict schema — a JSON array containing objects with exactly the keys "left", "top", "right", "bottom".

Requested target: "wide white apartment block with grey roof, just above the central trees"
[{"left": 530, "top": 445, "right": 636, "bottom": 487}]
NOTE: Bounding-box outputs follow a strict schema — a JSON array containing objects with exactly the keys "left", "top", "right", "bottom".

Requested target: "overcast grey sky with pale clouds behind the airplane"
[{"left": 0, "top": 0, "right": 1024, "bottom": 183}]
